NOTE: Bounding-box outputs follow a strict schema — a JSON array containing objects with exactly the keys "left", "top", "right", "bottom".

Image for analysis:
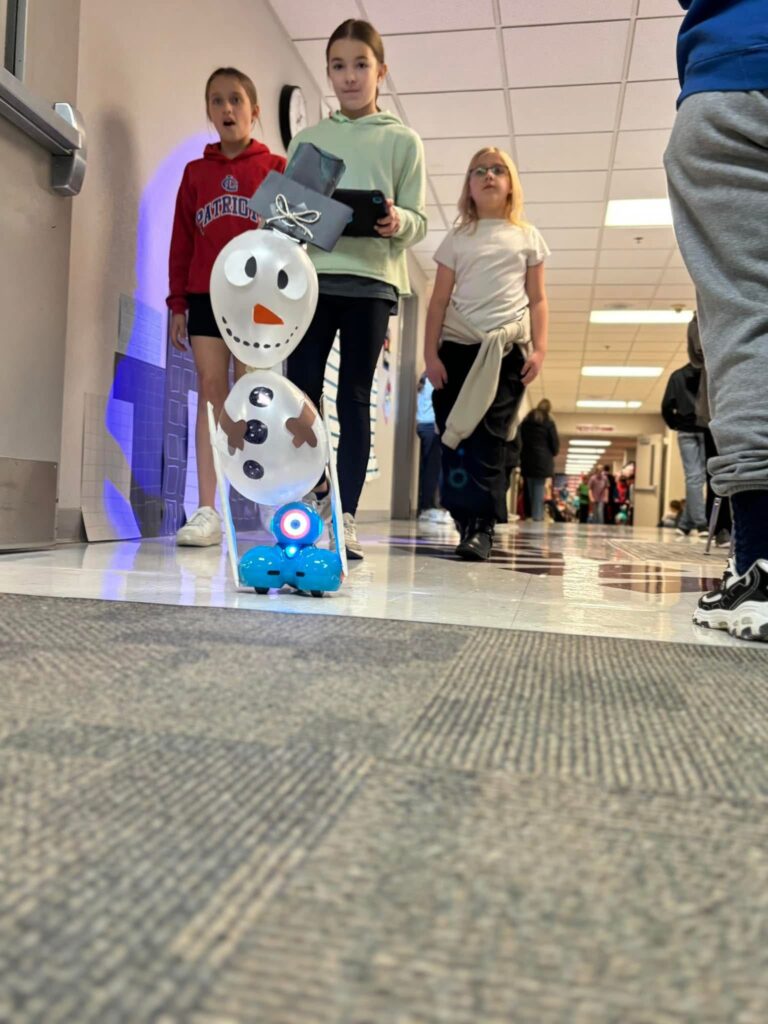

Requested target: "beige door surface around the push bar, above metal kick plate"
[{"left": 0, "top": 0, "right": 80, "bottom": 463}]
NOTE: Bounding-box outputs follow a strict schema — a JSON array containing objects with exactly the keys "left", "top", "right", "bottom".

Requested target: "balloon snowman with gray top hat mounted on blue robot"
[{"left": 208, "top": 160, "right": 348, "bottom": 597}]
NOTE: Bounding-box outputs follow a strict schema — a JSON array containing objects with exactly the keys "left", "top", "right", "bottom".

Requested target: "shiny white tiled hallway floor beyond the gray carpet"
[{"left": 0, "top": 522, "right": 741, "bottom": 645}]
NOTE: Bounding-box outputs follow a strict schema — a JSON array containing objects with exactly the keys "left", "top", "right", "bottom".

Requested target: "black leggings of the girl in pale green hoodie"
[{"left": 287, "top": 295, "right": 392, "bottom": 515}]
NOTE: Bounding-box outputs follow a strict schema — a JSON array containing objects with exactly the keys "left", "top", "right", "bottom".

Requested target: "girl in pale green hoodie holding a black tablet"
[{"left": 287, "top": 18, "right": 427, "bottom": 559}]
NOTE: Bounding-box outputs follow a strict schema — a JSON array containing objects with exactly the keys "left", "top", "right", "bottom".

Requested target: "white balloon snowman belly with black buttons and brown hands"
[{"left": 216, "top": 372, "right": 329, "bottom": 505}]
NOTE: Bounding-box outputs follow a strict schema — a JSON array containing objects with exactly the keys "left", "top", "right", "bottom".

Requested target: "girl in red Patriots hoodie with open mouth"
[{"left": 167, "top": 68, "right": 286, "bottom": 547}]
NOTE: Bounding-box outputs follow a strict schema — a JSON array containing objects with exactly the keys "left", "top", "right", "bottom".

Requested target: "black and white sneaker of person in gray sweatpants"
[{"left": 693, "top": 559, "right": 768, "bottom": 642}]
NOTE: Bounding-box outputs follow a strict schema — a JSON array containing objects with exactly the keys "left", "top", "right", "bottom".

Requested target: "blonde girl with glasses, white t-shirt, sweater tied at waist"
[{"left": 424, "top": 146, "right": 549, "bottom": 561}]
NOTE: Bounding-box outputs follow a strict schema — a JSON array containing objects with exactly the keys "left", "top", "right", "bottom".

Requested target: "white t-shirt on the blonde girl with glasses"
[{"left": 434, "top": 219, "right": 550, "bottom": 331}]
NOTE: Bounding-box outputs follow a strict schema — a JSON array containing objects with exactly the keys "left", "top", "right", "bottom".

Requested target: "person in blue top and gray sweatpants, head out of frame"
[{"left": 665, "top": 0, "right": 768, "bottom": 641}]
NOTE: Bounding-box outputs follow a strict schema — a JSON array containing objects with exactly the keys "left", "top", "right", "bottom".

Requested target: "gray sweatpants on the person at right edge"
[{"left": 665, "top": 91, "right": 768, "bottom": 495}]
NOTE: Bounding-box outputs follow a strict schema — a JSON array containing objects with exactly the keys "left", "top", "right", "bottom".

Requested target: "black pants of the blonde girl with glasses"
[{"left": 432, "top": 341, "right": 525, "bottom": 522}]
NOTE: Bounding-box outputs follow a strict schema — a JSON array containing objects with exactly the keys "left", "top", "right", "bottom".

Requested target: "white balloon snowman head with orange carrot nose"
[{"left": 211, "top": 229, "right": 317, "bottom": 369}]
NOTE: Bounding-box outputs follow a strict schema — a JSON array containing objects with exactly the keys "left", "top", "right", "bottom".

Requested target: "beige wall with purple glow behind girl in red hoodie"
[{"left": 59, "top": 0, "right": 319, "bottom": 515}]
